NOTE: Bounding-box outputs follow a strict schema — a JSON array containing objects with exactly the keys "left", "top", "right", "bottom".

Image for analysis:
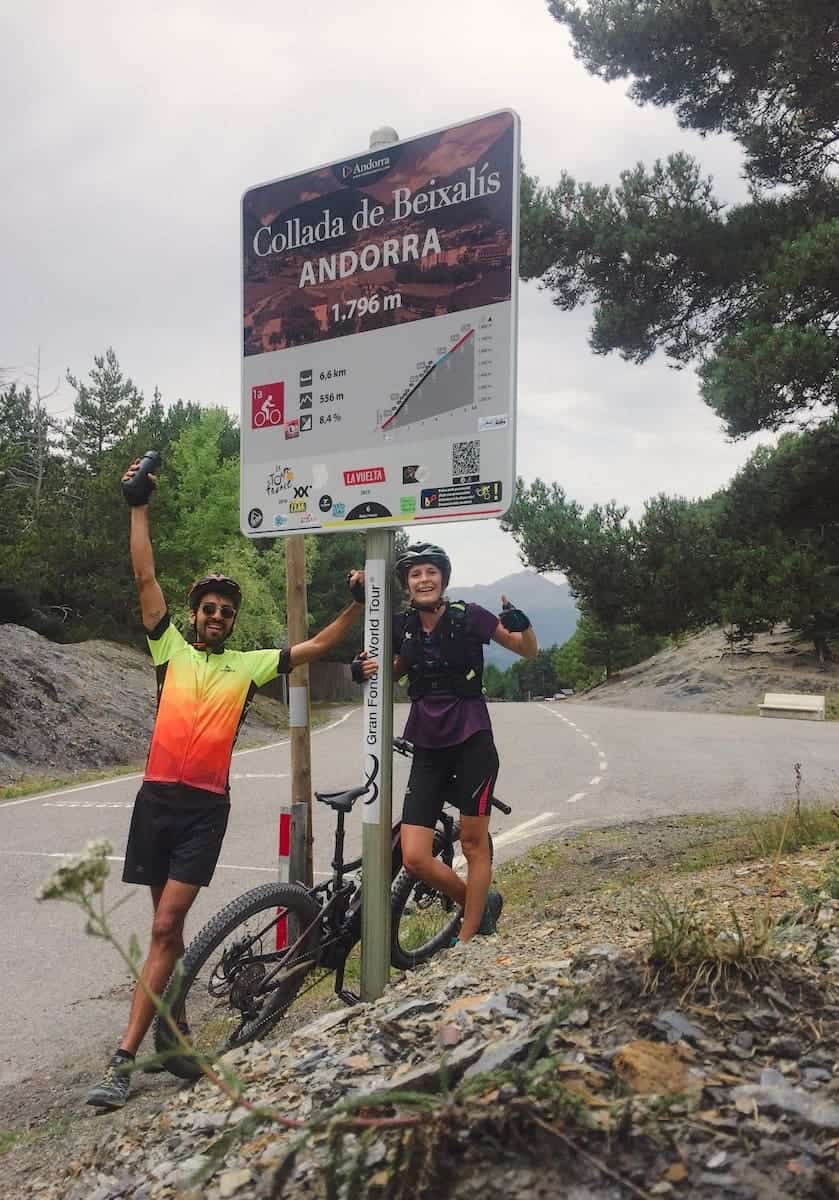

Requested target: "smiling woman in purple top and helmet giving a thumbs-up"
[{"left": 354, "top": 542, "right": 539, "bottom": 942}]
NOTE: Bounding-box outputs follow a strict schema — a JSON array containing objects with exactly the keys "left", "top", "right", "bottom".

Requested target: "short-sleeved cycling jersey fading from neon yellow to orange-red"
[{"left": 144, "top": 614, "right": 290, "bottom": 796}]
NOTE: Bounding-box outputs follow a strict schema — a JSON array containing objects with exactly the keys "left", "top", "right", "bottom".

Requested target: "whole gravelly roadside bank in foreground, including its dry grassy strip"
[{"left": 0, "top": 820, "right": 839, "bottom": 1200}]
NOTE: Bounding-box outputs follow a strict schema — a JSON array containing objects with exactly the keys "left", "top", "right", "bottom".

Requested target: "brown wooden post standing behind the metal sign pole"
[{"left": 289, "top": 534, "right": 314, "bottom": 887}]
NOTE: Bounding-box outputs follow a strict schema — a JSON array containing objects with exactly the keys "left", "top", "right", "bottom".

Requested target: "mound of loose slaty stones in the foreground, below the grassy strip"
[{"left": 16, "top": 913, "right": 839, "bottom": 1200}]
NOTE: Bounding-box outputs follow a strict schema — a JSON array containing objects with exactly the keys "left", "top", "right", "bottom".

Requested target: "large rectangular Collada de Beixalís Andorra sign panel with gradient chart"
[{"left": 241, "top": 110, "right": 519, "bottom": 538}]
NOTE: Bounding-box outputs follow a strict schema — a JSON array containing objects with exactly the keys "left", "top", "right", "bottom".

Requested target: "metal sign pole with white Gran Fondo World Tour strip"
[{"left": 361, "top": 126, "right": 398, "bottom": 1000}]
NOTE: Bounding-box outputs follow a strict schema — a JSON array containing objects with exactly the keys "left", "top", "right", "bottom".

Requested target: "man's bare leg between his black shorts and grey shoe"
[{"left": 119, "top": 880, "right": 200, "bottom": 1055}]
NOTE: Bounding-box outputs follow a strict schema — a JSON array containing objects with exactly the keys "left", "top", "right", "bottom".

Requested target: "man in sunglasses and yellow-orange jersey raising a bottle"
[{"left": 88, "top": 460, "right": 372, "bottom": 1109}]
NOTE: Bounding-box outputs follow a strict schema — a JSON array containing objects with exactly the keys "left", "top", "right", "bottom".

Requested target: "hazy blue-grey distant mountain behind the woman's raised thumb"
[{"left": 449, "top": 571, "right": 577, "bottom": 671}]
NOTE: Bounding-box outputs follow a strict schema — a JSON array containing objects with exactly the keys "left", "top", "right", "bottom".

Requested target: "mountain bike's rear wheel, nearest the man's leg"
[{"left": 155, "top": 883, "right": 320, "bottom": 1079}]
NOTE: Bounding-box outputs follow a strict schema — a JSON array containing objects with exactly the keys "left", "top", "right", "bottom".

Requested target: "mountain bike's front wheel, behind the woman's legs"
[{"left": 390, "top": 824, "right": 493, "bottom": 971}]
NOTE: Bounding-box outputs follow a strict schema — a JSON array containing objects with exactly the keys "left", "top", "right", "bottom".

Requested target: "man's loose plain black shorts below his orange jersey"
[{"left": 122, "top": 784, "right": 230, "bottom": 888}]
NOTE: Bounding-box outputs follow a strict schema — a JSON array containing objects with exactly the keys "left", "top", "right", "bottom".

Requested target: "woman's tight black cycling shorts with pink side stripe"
[{"left": 402, "top": 730, "right": 498, "bottom": 829}]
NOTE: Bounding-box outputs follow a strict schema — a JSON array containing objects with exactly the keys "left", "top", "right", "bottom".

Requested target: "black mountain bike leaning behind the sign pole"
[{"left": 155, "top": 738, "right": 513, "bottom": 1079}]
